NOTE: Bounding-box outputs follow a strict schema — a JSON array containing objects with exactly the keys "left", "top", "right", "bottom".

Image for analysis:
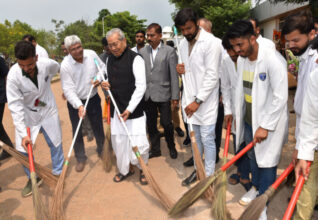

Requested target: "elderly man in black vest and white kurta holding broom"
[{"left": 102, "top": 28, "right": 149, "bottom": 184}]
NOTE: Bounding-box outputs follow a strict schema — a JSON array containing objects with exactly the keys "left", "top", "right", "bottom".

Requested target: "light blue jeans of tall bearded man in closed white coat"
[{"left": 193, "top": 124, "right": 216, "bottom": 176}]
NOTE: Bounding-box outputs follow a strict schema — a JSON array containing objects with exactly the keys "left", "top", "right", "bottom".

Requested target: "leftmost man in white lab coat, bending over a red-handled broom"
[{"left": 7, "top": 41, "right": 64, "bottom": 197}]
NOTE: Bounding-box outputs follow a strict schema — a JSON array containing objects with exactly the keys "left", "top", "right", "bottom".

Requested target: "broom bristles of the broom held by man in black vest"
[{"left": 133, "top": 147, "right": 174, "bottom": 210}]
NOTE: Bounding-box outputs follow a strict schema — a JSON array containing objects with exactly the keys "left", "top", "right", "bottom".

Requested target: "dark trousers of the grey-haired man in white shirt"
[{"left": 67, "top": 94, "right": 105, "bottom": 162}]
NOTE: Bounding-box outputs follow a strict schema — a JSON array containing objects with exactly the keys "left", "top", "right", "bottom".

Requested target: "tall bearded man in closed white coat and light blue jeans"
[{"left": 174, "top": 8, "right": 222, "bottom": 186}]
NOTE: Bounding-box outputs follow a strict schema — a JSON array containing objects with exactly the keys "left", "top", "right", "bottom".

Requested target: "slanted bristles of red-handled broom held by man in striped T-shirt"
[{"left": 169, "top": 170, "right": 222, "bottom": 216}]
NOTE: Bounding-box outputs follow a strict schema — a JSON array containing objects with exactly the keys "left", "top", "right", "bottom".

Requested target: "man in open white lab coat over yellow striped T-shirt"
[{"left": 227, "top": 20, "right": 288, "bottom": 219}]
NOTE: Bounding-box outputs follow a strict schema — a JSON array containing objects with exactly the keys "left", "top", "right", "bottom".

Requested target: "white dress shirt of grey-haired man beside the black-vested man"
[{"left": 61, "top": 49, "right": 105, "bottom": 109}]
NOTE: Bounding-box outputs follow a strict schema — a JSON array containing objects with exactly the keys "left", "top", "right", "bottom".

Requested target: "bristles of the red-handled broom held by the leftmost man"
[{"left": 30, "top": 172, "right": 49, "bottom": 220}]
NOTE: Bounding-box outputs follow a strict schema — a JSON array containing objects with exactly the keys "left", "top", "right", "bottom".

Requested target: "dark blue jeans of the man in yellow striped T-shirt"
[{"left": 244, "top": 122, "right": 277, "bottom": 195}]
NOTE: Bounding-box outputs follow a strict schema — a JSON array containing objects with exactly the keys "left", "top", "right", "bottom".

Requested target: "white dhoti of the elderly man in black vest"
[{"left": 111, "top": 115, "right": 149, "bottom": 175}]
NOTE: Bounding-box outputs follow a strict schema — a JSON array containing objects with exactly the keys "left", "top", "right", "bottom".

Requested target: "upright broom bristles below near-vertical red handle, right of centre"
[{"left": 212, "top": 158, "right": 232, "bottom": 220}]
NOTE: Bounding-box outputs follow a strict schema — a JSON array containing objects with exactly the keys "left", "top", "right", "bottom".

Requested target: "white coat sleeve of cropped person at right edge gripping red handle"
[{"left": 297, "top": 68, "right": 318, "bottom": 161}]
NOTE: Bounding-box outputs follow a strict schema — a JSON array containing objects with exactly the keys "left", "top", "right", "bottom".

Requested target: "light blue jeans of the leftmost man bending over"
[{"left": 20, "top": 127, "right": 64, "bottom": 179}]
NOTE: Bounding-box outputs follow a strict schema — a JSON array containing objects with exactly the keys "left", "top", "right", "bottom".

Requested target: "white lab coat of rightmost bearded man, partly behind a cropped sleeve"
[{"left": 294, "top": 47, "right": 318, "bottom": 149}]
